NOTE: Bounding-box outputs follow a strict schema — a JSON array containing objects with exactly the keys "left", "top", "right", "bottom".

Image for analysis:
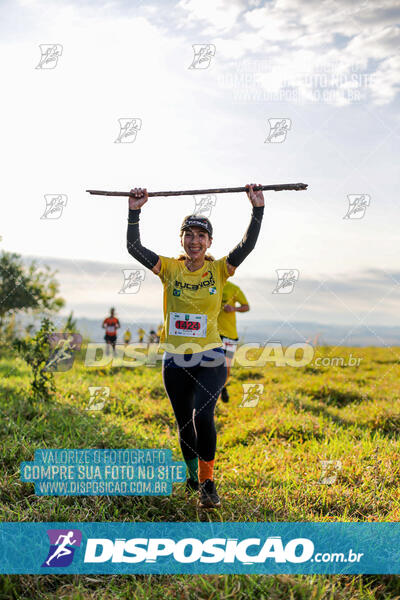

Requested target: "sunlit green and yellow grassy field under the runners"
[{"left": 0, "top": 348, "right": 400, "bottom": 600}]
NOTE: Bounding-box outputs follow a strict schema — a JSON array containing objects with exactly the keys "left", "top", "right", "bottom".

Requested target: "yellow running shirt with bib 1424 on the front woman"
[{"left": 158, "top": 256, "right": 230, "bottom": 354}]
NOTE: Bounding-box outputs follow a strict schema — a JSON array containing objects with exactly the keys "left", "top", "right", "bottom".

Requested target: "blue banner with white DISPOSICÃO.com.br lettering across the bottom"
[{"left": 0, "top": 522, "right": 400, "bottom": 574}]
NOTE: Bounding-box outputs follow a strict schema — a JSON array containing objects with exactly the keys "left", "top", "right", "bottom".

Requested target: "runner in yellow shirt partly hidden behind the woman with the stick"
[{"left": 218, "top": 281, "right": 250, "bottom": 402}]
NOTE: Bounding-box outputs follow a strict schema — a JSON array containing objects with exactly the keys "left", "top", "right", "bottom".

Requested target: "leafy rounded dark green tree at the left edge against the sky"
[{"left": 0, "top": 251, "right": 65, "bottom": 329}]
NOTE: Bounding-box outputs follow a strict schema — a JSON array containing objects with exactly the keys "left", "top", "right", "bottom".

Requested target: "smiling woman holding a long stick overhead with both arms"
[{"left": 127, "top": 184, "right": 264, "bottom": 508}]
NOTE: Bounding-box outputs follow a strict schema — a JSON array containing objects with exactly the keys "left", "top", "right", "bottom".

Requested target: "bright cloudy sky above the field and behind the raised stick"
[{"left": 0, "top": 0, "right": 400, "bottom": 332}]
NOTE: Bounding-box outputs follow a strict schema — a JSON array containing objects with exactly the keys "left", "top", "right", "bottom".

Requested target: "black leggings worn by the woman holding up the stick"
[{"left": 163, "top": 348, "right": 227, "bottom": 461}]
